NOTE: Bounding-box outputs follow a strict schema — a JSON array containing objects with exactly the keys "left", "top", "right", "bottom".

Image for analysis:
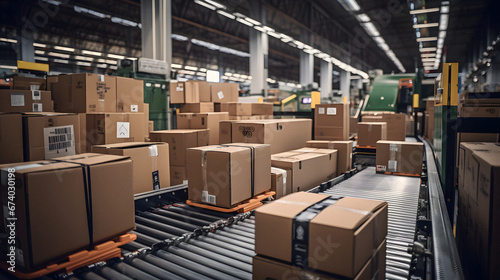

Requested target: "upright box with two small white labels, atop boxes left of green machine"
[{"left": 314, "top": 103, "right": 350, "bottom": 141}]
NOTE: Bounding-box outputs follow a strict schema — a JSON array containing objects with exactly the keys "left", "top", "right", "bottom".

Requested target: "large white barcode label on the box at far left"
[{"left": 43, "top": 125, "right": 76, "bottom": 159}]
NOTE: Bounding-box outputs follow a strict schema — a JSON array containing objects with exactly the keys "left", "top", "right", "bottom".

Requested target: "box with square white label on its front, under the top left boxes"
[{"left": 87, "top": 113, "right": 146, "bottom": 151}]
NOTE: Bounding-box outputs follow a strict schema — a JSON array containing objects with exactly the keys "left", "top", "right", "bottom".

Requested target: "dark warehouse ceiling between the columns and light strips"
[{"left": 0, "top": 0, "right": 491, "bottom": 82}]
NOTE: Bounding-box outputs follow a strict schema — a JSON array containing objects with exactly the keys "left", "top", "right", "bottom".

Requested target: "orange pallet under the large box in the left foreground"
[{"left": 0, "top": 233, "right": 137, "bottom": 279}]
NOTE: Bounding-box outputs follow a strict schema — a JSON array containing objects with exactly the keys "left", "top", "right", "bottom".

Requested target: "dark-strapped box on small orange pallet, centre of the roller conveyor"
[{"left": 187, "top": 143, "right": 271, "bottom": 207}]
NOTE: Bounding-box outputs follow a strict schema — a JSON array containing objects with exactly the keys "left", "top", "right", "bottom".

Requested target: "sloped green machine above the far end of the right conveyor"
[{"left": 363, "top": 73, "right": 421, "bottom": 113}]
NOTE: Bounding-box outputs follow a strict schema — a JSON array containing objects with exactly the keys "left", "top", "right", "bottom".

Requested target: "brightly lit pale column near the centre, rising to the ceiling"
[{"left": 249, "top": 1, "right": 269, "bottom": 97}]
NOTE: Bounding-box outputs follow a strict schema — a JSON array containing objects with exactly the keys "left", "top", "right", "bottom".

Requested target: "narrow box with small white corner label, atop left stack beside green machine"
[{"left": 116, "top": 77, "right": 144, "bottom": 113}]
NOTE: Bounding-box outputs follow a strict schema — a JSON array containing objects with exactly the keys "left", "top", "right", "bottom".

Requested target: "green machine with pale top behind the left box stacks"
[{"left": 117, "top": 58, "right": 171, "bottom": 130}]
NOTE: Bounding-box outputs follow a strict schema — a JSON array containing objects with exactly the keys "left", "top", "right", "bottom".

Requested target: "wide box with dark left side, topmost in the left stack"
[{"left": 52, "top": 73, "right": 116, "bottom": 113}]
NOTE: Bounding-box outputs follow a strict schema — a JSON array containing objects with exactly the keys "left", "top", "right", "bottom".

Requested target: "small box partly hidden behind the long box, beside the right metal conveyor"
[{"left": 307, "top": 140, "right": 353, "bottom": 176}]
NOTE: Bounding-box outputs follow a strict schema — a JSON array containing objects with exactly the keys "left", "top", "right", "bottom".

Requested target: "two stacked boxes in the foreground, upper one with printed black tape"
[{"left": 253, "top": 192, "right": 388, "bottom": 280}]
